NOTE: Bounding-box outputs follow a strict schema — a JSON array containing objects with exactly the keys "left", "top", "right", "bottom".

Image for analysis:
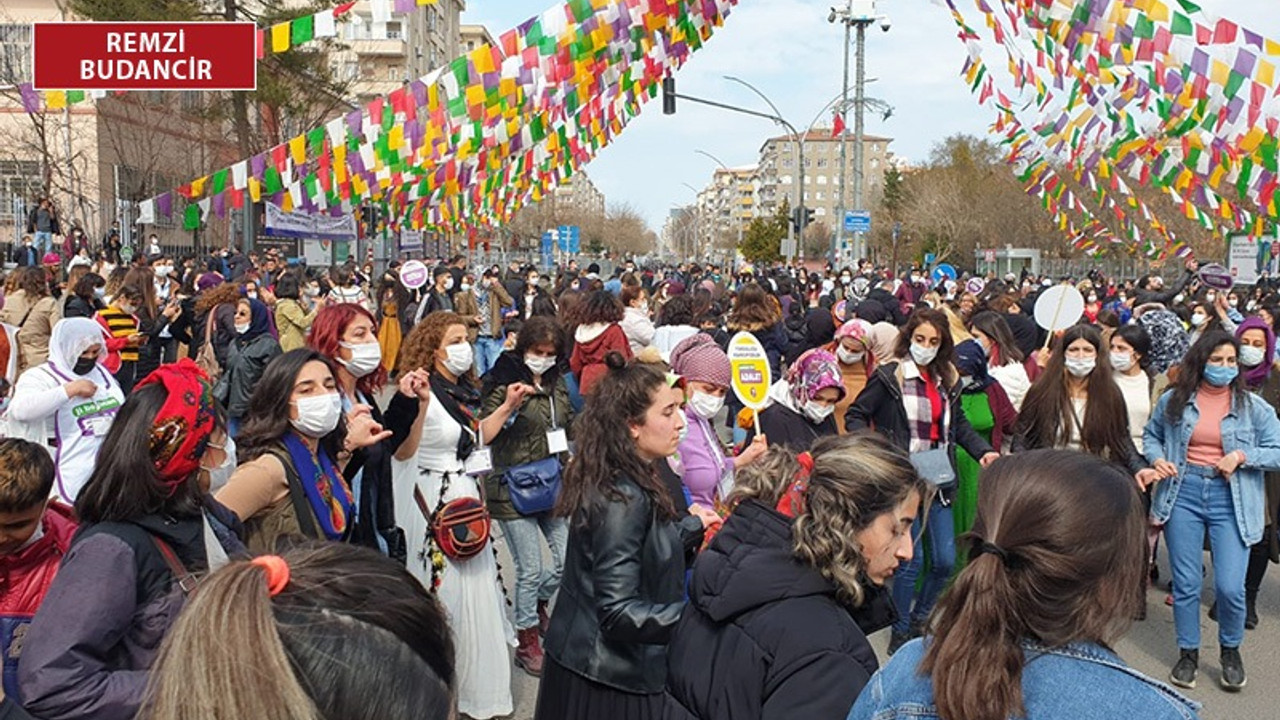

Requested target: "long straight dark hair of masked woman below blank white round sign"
[{"left": 1018, "top": 325, "right": 1133, "bottom": 461}]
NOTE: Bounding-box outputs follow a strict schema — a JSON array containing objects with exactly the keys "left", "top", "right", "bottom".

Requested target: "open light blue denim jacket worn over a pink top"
[{"left": 1142, "top": 392, "right": 1280, "bottom": 546}]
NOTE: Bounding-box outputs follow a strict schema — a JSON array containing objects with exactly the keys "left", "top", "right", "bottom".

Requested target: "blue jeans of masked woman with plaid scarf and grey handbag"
[{"left": 893, "top": 500, "right": 956, "bottom": 633}]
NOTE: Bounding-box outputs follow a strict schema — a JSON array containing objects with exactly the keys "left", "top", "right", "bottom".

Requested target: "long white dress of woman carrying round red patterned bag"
[{"left": 394, "top": 393, "right": 516, "bottom": 720}]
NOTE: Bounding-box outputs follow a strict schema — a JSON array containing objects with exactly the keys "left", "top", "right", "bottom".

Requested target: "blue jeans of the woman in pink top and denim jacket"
[{"left": 1165, "top": 465, "right": 1249, "bottom": 650}]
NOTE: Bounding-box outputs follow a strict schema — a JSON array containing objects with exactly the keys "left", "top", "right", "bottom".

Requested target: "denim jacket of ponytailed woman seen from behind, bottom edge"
[{"left": 846, "top": 639, "right": 1199, "bottom": 720}]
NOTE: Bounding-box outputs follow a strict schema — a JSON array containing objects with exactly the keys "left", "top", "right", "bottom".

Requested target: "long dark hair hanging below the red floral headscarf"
[{"left": 76, "top": 383, "right": 207, "bottom": 523}]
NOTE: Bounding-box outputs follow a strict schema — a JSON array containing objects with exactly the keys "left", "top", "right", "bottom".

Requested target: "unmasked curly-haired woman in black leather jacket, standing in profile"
[{"left": 534, "top": 352, "right": 719, "bottom": 720}]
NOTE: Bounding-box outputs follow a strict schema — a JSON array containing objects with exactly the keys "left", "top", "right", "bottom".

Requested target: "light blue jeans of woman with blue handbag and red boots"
[{"left": 498, "top": 512, "right": 568, "bottom": 630}]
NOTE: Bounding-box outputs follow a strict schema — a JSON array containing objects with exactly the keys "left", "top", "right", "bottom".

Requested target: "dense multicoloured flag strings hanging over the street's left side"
[{"left": 129, "top": 0, "right": 736, "bottom": 231}]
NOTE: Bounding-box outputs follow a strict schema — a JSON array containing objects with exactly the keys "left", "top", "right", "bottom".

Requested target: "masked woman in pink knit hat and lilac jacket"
[{"left": 668, "top": 333, "right": 768, "bottom": 509}]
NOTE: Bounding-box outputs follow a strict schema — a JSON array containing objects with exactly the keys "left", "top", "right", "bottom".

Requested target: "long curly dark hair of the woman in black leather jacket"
[{"left": 556, "top": 352, "right": 676, "bottom": 524}]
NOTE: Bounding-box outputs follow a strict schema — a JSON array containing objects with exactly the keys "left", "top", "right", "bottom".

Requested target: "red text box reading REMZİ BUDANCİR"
[{"left": 32, "top": 22, "right": 257, "bottom": 90}]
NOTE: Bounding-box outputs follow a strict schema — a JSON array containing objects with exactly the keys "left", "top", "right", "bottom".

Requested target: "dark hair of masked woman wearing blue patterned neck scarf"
[{"left": 236, "top": 347, "right": 347, "bottom": 460}]
